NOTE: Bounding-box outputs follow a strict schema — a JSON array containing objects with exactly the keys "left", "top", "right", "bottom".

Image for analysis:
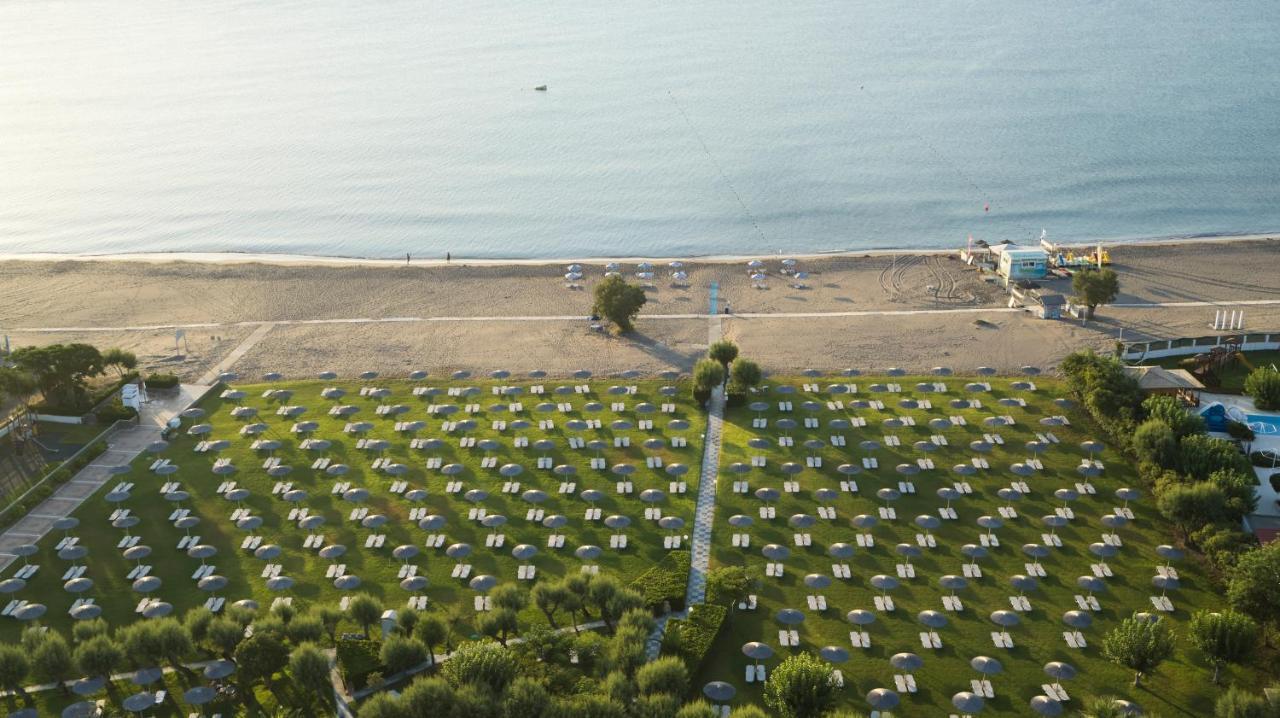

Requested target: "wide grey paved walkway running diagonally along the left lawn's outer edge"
[{"left": 0, "top": 384, "right": 209, "bottom": 573}]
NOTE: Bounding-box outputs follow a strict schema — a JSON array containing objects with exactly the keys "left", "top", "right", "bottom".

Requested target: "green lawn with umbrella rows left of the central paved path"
[{"left": 0, "top": 379, "right": 703, "bottom": 640}]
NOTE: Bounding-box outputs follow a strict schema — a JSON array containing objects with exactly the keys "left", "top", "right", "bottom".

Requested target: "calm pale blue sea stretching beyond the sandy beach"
[{"left": 0, "top": 0, "right": 1280, "bottom": 257}]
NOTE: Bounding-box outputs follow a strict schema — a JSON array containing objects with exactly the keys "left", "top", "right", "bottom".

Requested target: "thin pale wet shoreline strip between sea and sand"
[{"left": 0, "top": 232, "right": 1280, "bottom": 266}]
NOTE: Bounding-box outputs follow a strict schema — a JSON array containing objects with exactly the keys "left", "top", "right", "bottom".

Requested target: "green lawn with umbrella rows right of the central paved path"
[{"left": 696, "top": 376, "right": 1262, "bottom": 717}]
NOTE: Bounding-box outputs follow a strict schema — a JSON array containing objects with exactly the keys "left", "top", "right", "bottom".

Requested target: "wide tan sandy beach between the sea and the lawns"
[{"left": 0, "top": 238, "right": 1280, "bottom": 379}]
